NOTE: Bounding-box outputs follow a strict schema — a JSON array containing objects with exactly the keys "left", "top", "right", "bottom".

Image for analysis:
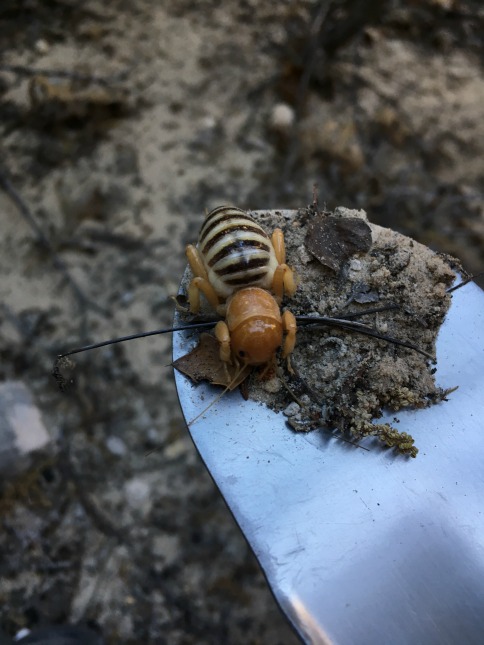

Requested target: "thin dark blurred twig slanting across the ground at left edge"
[{"left": 0, "top": 170, "right": 108, "bottom": 316}]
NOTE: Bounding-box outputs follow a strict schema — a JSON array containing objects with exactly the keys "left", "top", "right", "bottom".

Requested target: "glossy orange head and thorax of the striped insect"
[{"left": 226, "top": 287, "right": 282, "bottom": 365}]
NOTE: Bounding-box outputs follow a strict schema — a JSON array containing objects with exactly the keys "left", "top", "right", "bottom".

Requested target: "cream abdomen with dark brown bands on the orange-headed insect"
[{"left": 198, "top": 206, "right": 278, "bottom": 298}]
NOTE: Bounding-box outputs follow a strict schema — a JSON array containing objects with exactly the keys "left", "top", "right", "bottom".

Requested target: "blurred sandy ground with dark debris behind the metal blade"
[{"left": 0, "top": 0, "right": 484, "bottom": 644}]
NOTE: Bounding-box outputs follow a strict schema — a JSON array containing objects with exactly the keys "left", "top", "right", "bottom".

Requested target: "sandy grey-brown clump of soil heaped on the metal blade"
[{"left": 182, "top": 205, "right": 456, "bottom": 457}]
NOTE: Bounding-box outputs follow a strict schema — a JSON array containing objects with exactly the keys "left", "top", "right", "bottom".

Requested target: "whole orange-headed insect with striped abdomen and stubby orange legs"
[{"left": 186, "top": 206, "right": 297, "bottom": 366}]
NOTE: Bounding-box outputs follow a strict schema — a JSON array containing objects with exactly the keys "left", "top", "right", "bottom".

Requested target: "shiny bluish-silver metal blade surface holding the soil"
[{"left": 173, "top": 262, "right": 484, "bottom": 645}]
